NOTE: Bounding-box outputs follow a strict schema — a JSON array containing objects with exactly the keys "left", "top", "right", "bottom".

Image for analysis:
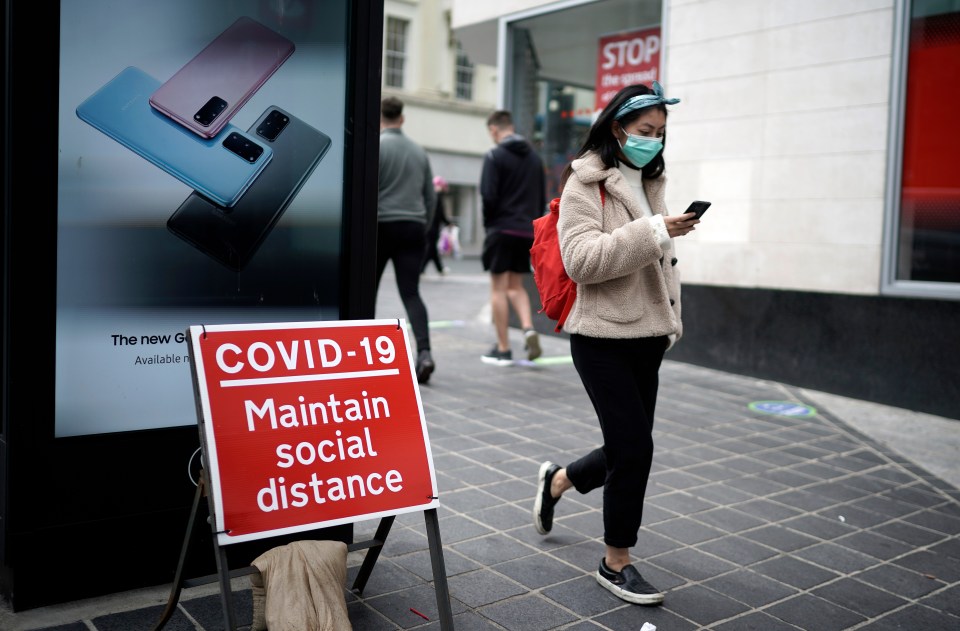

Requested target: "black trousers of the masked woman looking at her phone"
[{"left": 567, "top": 335, "right": 667, "bottom": 548}]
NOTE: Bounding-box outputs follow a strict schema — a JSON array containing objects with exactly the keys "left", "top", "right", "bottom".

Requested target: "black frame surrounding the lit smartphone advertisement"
[{"left": 0, "top": 0, "right": 383, "bottom": 611}]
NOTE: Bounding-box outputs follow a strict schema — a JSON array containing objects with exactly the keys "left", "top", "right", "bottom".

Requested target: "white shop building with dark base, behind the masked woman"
[{"left": 451, "top": 0, "right": 960, "bottom": 418}]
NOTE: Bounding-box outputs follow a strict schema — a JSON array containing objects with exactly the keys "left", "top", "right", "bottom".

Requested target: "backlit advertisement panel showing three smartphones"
[{"left": 55, "top": 0, "right": 348, "bottom": 437}]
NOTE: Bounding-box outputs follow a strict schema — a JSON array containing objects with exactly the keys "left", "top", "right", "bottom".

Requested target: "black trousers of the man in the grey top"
[{"left": 377, "top": 221, "right": 430, "bottom": 353}]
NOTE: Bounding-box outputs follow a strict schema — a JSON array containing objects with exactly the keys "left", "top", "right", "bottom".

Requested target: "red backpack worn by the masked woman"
[{"left": 530, "top": 182, "right": 605, "bottom": 333}]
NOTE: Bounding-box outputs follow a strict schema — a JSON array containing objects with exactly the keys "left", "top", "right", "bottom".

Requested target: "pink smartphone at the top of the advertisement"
[{"left": 150, "top": 16, "right": 295, "bottom": 138}]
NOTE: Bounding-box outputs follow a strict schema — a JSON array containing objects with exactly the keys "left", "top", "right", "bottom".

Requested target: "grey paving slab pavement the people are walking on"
[{"left": 0, "top": 254, "right": 960, "bottom": 631}]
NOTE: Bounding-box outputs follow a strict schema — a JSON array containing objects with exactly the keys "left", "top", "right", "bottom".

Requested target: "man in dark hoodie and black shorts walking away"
[{"left": 480, "top": 110, "right": 547, "bottom": 366}]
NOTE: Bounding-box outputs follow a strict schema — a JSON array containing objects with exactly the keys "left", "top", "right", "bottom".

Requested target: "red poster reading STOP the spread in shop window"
[{"left": 594, "top": 26, "right": 660, "bottom": 112}]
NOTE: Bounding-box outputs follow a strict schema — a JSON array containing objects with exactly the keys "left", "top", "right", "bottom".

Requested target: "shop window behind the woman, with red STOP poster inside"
[{"left": 500, "top": 0, "right": 665, "bottom": 198}]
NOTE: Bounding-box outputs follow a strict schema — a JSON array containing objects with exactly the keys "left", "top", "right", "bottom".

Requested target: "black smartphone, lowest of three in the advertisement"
[{"left": 167, "top": 106, "right": 331, "bottom": 271}]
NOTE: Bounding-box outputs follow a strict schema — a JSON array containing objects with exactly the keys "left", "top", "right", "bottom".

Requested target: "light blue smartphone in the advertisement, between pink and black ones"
[{"left": 77, "top": 66, "right": 273, "bottom": 207}]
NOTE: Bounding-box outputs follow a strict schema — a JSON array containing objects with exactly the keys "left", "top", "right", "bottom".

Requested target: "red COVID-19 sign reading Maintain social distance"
[{"left": 189, "top": 320, "right": 438, "bottom": 544}]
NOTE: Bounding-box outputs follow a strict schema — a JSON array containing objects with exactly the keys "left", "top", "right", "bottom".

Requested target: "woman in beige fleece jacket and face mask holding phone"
[{"left": 533, "top": 82, "right": 699, "bottom": 605}]
